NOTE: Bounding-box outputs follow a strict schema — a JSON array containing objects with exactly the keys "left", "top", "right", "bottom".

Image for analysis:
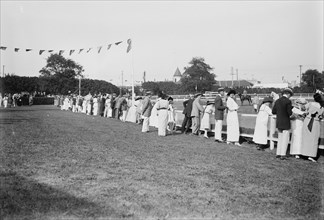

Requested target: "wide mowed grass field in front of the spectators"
[{"left": 0, "top": 106, "right": 324, "bottom": 219}]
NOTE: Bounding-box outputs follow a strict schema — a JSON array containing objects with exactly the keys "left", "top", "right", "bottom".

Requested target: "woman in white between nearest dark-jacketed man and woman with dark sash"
[{"left": 290, "top": 98, "right": 307, "bottom": 159}]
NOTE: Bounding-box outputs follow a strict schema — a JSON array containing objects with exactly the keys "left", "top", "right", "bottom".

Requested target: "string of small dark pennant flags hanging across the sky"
[{"left": 0, "top": 39, "right": 132, "bottom": 56}]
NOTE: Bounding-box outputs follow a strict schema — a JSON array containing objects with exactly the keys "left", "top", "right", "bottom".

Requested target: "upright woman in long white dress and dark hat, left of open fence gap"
[{"left": 226, "top": 89, "right": 241, "bottom": 146}]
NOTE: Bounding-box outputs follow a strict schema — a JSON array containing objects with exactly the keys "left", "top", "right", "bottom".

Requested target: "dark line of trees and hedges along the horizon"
[{"left": 0, "top": 54, "right": 324, "bottom": 95}]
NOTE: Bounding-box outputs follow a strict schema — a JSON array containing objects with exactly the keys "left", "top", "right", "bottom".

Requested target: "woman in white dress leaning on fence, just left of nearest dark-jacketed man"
[{"left": 253, "top": 97, "right": 273, "bottom": 150}]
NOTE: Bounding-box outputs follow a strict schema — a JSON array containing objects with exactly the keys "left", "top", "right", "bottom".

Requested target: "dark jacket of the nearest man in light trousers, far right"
[{"left": 272, "top": 96, "right": 292, "bottom": 130}]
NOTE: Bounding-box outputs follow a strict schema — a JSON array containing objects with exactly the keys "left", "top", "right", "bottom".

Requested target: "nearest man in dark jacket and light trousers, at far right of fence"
[{"left": 272, "top": 88, "right": 293, "bottom": 160}]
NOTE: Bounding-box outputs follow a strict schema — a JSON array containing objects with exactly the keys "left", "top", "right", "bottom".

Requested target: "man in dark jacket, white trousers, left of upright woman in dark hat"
[{"left": 215, "top": 88, "right": 226, "bottom": 143}]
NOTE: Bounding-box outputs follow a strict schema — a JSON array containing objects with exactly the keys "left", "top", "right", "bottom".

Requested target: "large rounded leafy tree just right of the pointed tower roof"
[{"left": 181, "top": 57, "right": 216, "bottom": 92}]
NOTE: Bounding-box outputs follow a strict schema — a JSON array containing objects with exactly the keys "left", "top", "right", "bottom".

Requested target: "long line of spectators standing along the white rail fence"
[{"left": 56, "top": 88, "right": 324, "bottom": 162}]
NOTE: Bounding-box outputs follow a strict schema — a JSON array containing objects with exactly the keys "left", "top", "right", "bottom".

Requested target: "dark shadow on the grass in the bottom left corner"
[{"left": 0, "top": 171, "right": 116, "bottom": 219}]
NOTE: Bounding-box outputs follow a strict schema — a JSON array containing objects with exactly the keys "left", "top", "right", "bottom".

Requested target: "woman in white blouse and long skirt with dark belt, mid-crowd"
[{"left": 154, "top": 93, "right": 169, "bottom": 136}]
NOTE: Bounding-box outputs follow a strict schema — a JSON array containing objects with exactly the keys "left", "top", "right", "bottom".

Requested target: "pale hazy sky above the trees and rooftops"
[{"left": 0, "top": 0, "right": 324, "bottom": 85}]
